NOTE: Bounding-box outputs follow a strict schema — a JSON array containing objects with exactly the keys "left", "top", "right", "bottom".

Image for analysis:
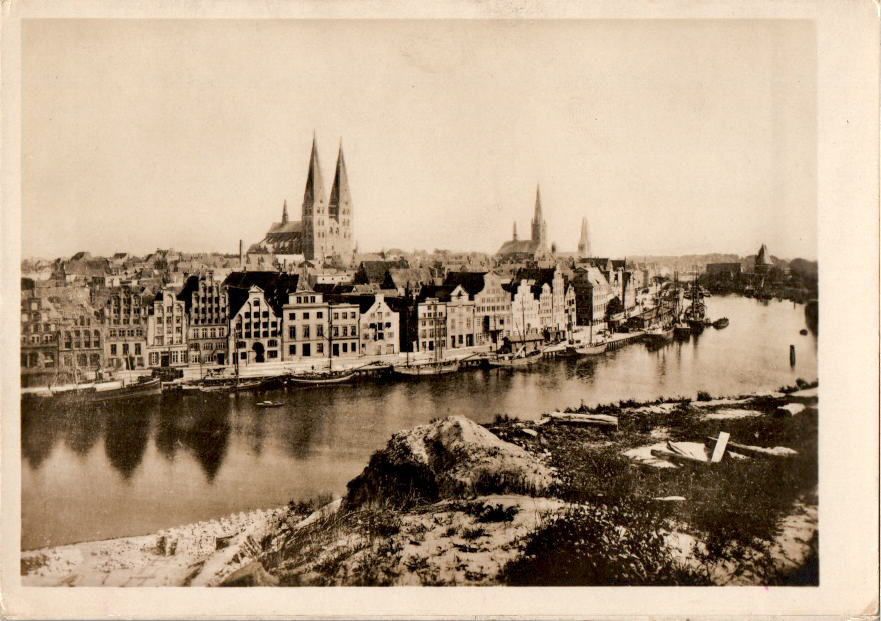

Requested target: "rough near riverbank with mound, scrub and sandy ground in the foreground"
[{"left": 22, "top": 378, "right": 818, "bottom": 586}]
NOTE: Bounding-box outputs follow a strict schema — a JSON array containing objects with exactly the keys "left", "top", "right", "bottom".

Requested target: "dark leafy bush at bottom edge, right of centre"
[{"left": 500, "top": 503, "right": 709, "bottom": 586}]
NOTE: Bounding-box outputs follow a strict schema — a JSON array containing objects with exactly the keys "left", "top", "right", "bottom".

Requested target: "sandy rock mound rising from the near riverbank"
[{"left": 345, "top": 416, "right": 554, "bottom": 509}]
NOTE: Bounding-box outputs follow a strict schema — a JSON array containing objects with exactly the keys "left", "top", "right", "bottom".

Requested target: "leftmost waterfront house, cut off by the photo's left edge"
[{"left": 20, "top": 278, "right": 61, "bottom": 387}]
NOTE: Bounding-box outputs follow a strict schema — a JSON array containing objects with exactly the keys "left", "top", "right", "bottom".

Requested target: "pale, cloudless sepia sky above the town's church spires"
[{"left": 22, "top": 19, "right": 817, "bottom": 259}]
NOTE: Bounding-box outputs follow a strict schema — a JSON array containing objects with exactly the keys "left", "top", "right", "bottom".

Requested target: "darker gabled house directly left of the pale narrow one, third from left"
[{"left": 101, "top": 286, "right": 154, "bottom": 369}]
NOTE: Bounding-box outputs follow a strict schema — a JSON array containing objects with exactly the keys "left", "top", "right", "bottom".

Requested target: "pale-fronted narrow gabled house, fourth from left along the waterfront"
[{"left": 147, "top": 288, "right": 189, "bottom": 367}]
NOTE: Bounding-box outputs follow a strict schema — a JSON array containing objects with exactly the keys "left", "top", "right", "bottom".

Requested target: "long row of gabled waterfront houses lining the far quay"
[{"left": 21, "top": 259, "right": 644, "bottom": 385}]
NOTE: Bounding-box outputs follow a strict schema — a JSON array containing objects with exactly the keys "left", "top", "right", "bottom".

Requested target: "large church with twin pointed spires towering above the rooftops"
[{"left": 248, "top": 137, "right": 355, "bottom": 265}]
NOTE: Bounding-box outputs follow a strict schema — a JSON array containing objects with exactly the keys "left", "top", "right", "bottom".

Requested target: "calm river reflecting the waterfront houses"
[{"left": 22, "top": 296, "right": 817, "bottom": 549}]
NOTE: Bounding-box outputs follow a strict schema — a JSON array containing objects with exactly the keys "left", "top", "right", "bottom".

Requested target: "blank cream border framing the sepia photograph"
[{"left": 0, "top": 0, "right": 879, "bottom": 618}]
